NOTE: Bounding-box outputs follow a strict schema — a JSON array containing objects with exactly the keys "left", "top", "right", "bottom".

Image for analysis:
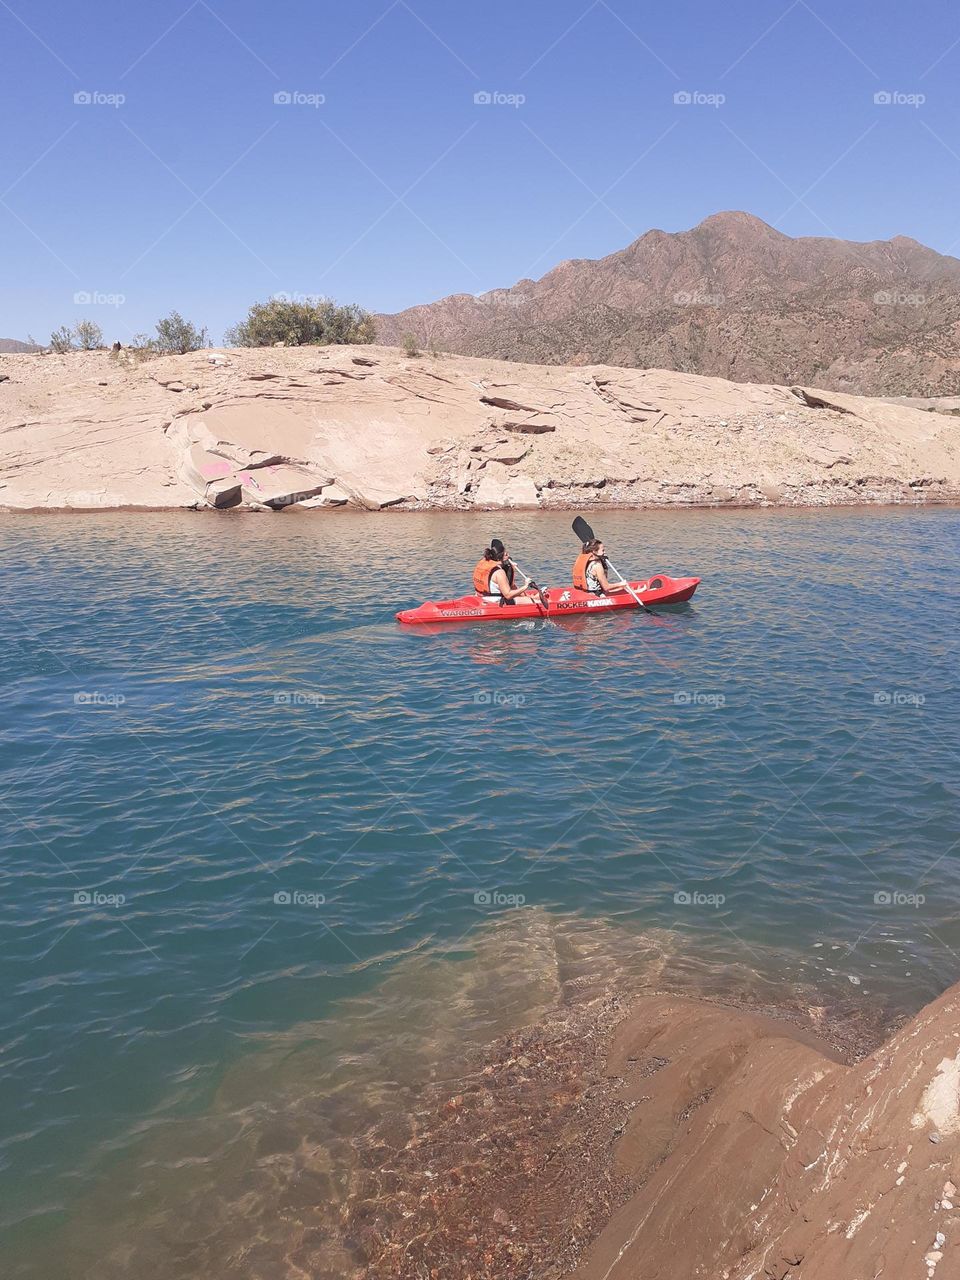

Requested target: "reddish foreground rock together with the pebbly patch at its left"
[{"left": 358, "top": 987, "right": 960, "bottom": 1280}]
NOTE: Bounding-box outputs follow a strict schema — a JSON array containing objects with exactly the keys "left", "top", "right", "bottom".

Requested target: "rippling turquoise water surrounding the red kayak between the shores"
[{"left": 0, "top": 509, "right": 960, "bottom": 1280}]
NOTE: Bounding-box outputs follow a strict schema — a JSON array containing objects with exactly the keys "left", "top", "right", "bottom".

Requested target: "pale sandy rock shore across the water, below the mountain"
[{"left": 0, "top": 347, "right": 960, "bottom": 511}]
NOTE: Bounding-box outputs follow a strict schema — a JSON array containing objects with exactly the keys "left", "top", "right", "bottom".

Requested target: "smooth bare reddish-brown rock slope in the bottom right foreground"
[{"left": 576, "top": 987, "right": 960, "bottom": 1280}]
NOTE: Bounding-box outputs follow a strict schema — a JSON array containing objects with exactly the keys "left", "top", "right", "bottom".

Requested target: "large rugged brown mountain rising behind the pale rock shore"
[{"left": 378, "top": 211, "right": 960, "bottom": 396}]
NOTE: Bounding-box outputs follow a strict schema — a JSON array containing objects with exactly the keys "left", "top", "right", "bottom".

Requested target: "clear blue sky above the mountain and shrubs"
[{"left": 0, "top": 0, "right": 960, "bottom": 340}]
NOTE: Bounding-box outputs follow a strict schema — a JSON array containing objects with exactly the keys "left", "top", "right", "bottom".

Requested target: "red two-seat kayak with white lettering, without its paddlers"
[{"left": 397, "top": 573, "right": 700, "bottom": 626}]
